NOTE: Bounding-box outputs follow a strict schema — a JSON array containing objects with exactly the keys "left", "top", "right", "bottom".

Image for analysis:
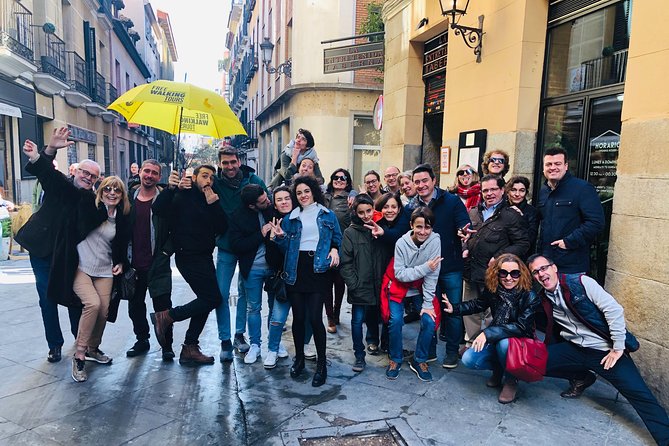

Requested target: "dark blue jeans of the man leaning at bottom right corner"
[{"left": 546, "top": 342, "right": 669, "bottom": 445}]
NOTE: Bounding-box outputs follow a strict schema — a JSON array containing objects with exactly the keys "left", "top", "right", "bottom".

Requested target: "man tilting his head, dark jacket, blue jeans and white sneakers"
[{"left": 230, "top": 184, "right": 272, "bottom": 364}]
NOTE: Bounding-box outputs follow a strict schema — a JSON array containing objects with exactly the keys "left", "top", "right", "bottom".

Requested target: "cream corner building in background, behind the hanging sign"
[{"left": 227, "top": 0, "right": 382, "bottom": 182}]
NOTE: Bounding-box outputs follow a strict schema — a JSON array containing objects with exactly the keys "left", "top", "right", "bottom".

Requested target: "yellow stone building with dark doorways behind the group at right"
[{"left": 381, "top": 0, "right": 669, "bottom": 405}]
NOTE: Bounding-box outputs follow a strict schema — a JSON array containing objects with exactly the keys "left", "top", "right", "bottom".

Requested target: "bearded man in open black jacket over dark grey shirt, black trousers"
[{"left": 126, "top": 159, "right": 174, "bottom": 361}]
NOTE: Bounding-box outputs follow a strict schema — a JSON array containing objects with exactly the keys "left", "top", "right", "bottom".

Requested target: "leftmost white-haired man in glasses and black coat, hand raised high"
[{"left": 16, "top": 127, "right": 100, "bottom": 362}]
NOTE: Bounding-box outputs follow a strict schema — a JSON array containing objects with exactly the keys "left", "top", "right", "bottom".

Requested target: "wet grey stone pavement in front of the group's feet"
[{"left": 0, "top": 260, "right": 653, "bottom": 446}]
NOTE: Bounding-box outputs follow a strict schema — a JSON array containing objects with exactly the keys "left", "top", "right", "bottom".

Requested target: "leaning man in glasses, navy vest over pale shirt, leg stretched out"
[{"left": 528, "top": 254, "right": 669, "bottom": 445}]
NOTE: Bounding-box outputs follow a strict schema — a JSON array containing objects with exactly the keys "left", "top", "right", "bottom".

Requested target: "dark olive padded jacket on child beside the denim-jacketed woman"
[{"left": 339, "top": 222, "right": 386, "bottom": 305}]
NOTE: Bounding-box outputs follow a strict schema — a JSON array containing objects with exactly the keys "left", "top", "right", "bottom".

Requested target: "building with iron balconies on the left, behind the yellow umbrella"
[{"left": 0, "top": 0, "right": 176, "bottom": 202}]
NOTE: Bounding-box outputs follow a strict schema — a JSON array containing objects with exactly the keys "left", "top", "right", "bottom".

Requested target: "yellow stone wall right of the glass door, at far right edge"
[{"left": 606, "top": 0, "right": 669, "bottom": 407}]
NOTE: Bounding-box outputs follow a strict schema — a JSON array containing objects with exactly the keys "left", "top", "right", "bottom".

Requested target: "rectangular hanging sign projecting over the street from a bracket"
[{"left": 323, "top": 42, "right": 385, "bottom": 74}]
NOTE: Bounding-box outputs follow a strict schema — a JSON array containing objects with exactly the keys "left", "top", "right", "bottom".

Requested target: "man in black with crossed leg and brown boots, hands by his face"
[{"left": 151, "top": 165, "right": 228, "bottom": 365}]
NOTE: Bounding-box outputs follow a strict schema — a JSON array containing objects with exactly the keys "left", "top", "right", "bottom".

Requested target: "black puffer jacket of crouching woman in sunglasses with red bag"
[{"left": 453, "top": 289, "right": 541, "bottom": 343}]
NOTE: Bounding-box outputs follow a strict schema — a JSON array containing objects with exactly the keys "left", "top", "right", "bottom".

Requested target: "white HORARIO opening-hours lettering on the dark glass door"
[{"left": 588, "top": 130, "right": 620, "bottom": 201}]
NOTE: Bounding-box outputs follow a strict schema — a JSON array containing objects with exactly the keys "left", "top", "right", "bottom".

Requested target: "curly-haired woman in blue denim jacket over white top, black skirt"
[{"left": 273, "top": 176, "right": 342, "bottom": 387}]
